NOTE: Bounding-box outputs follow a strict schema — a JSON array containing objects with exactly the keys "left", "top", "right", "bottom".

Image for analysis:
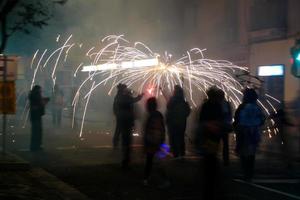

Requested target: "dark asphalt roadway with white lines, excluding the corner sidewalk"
[{"left": 10, "top": 146, "right": 300, "bottom": 199}]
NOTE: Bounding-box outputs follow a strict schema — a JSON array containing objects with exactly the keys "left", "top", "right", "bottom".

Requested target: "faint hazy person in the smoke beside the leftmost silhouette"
[{"left": 51, "top": 85, "right": 64, "bottom": 127}]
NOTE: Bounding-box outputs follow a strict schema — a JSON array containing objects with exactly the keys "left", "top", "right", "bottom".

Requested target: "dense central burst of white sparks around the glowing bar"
[{"left": 82, "top": 36, "right": 247, "bottom": 106}]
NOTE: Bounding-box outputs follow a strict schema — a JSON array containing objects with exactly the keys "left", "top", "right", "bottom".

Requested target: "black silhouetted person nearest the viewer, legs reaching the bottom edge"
[{"left": 197, "top": 87, "right": 224, "bottom": 199}]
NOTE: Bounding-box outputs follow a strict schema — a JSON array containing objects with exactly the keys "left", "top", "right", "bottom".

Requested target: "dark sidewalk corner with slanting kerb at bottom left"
[{"left": 0, "top": 152, "right": 89, "bottom": 200}]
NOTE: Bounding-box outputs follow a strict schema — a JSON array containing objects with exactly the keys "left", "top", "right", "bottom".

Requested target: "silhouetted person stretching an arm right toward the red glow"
[{"left": 118, "top": 84, "right": 144, "bottom": 169}]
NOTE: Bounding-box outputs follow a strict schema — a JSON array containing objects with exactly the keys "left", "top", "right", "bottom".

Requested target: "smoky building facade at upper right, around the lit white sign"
[{"left": 183, "top": 0, "right": 300, "bottom": 102}]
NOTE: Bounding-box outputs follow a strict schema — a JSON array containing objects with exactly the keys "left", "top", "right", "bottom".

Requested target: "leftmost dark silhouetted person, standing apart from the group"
[{"left": 28, "top": 85, "right": 49, "bottom": 151}]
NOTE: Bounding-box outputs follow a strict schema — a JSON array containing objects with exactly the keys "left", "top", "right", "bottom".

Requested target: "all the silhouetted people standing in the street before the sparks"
[{"left": 29, "top": 84, "right": 265, "bottom": 199}]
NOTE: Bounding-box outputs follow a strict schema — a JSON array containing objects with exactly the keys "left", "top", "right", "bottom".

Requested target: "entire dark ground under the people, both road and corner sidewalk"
[{"left": 0, "top": 113, "right": 300, "bottom": 200}]
